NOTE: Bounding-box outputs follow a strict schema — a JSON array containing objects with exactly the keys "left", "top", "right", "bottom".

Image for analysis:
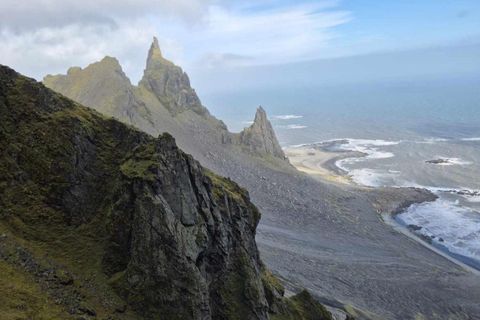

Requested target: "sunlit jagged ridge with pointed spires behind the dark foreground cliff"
[{"left": 43, "top": 38, "right": 285, "bottom": 163}]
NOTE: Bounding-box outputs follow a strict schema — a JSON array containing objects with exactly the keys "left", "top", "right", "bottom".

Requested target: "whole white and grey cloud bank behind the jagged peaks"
[{"left": 0, "top": 0, "right": 351, "bottom": 82}]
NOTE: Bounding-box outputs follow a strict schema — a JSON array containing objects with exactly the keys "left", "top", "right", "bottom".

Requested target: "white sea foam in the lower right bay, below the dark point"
[{"left": 397, "top": 199, "right": 480, "bottom": 261}]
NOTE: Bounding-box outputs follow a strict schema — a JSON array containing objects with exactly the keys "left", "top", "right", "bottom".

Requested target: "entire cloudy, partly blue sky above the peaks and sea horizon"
[{"left": 0, "top": 0, "right": 480, "bottom": 83}]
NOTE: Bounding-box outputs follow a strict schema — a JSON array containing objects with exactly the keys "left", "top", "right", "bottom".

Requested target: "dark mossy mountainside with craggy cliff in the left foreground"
[{"left": 0, "top": 66, "right": 330, "bottom": 320}]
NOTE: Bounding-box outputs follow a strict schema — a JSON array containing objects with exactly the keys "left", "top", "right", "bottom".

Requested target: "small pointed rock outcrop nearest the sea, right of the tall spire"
[{"left": 239, "top": 107, "right": 285, "bottom": 159}]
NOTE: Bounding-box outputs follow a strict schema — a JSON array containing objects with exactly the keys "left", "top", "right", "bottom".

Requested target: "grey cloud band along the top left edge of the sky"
[{"left": 0, "top": 0, "right": 210, "bottom": 31}]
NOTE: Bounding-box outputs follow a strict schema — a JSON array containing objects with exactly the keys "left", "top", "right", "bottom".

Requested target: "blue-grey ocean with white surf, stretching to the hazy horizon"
[{"left": 204, "top": 76, "right": 480, "bottom": 269}]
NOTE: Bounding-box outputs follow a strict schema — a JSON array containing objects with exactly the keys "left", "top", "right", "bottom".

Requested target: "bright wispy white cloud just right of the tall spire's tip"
[{"left": 192, "top": 1, "right": 352, "bottom": 64}]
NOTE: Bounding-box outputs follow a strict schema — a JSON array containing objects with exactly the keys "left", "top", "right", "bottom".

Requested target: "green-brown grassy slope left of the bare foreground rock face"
[{"left": 0, "top": 68, "right": 328, "bottom": 319}]
